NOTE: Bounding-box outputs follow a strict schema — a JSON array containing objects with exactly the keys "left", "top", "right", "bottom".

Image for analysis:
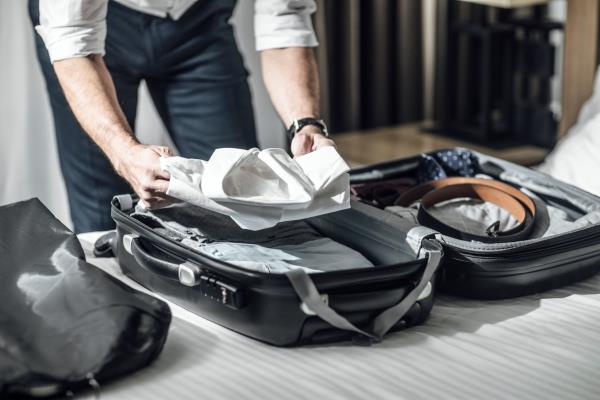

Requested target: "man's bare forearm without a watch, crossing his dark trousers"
[{"left": 54, "top": 55, "right": 138, "bottom": 170}]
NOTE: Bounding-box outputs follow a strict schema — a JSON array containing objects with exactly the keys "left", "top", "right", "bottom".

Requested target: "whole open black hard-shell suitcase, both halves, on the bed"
[{"left": 112, "top": 149, "right": 600, "bottom": 346}]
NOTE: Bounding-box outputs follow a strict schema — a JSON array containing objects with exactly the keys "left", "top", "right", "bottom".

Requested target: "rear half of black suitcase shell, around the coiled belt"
[{"left": 351, "top": 149, "right": 600, "bottom": 299}]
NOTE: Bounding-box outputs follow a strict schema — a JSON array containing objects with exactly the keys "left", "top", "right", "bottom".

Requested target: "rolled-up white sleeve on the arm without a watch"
[{"left": 35, "top": 0, "right": 108, "bottom": 62}]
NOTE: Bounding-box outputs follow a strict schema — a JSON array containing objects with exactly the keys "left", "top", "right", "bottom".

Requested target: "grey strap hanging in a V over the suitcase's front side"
[{"left": 286, "top": 240, "right": 442, "bottom": 341}]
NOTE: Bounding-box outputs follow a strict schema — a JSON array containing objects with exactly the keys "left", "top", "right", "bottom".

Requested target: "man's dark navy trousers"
[{"left": 29, "top": 0, "right": 257, "bottom": 232}]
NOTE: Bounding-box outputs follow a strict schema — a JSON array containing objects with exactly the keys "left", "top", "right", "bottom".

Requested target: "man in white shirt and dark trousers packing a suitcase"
[{"left": 29, "top": 0, "right": 333, "bottom": 232}]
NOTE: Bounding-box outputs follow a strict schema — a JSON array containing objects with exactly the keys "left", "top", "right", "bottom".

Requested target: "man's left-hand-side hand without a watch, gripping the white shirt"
[{"left": 113, "top": 143, "right": 173, "bottom": 208}]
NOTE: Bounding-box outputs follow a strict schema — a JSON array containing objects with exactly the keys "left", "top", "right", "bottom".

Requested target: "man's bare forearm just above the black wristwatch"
[{"left": 261, "top": 47, "right": 320, "bottom": 127}]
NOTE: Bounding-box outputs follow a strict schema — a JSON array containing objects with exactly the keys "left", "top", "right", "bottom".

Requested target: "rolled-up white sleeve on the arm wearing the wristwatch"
[{"left": 254, "top": 0, "right": 319, "bottom": 51}]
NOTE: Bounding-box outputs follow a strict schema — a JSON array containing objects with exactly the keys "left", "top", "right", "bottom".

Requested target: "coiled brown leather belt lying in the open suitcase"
[{"left": 395, "top": 177, "right": 537, "bottom": 243}]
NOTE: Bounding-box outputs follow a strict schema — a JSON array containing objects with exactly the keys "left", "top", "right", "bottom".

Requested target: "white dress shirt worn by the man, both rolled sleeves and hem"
[{"left": 36, "top": 0, "right": 318, "bottom": 62}]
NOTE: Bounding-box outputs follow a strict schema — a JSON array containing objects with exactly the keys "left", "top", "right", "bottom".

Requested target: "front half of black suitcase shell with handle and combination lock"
[{"left": 111, "top": 195, "right": 442, "bottom": 346}]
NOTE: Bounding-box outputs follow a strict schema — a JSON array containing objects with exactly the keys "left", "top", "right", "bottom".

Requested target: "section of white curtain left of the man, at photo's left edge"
[{"left": 0, "top": 0, "right": 69, "bottom": 223}]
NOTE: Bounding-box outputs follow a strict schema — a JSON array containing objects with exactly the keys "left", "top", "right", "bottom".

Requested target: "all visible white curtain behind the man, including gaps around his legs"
[{"left": 0, "top": 0, "right": 284, "bottom": 230}]
